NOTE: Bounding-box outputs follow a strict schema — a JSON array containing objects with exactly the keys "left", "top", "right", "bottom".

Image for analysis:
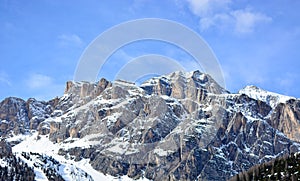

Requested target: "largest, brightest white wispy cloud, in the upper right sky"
[{"left": 187, "top": 0, "right": 272, "bottom": 34}]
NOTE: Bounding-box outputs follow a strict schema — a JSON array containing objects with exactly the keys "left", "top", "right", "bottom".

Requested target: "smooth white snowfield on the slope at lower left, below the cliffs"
[{"left": 12, "top": 132, "right": 148, "bottom": 181}]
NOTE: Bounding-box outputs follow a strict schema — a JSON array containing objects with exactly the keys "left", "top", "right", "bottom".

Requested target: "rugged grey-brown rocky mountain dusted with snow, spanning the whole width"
[{"left": 0, "top": 71, "right": 300, "bottom": 180}]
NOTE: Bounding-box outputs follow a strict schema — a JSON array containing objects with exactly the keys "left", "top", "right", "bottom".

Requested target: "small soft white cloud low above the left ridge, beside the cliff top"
[{"left": 26, "top": 73, "right": 53, "bottom": 89}]
